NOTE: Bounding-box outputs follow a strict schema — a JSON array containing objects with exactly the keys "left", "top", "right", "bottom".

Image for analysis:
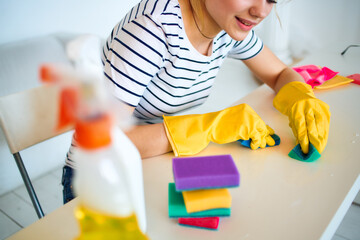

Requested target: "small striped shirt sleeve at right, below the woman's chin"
[{"left": 228, "top": 30, "right": 264, "bottom": 60}]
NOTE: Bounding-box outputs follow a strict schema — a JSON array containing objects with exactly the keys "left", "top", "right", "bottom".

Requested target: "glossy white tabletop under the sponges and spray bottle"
[{"left": 10, "top": 54, "right": 360, "bottom": 240}]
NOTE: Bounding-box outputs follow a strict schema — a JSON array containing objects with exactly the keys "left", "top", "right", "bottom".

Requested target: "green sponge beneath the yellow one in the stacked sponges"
[{"left": 169, "top": 183, "right": 231, "bottom": 218}]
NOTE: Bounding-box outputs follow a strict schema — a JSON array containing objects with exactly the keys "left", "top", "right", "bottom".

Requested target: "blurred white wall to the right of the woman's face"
[{"left": 257, "top": 0, "right": 360, "bottom": 63}]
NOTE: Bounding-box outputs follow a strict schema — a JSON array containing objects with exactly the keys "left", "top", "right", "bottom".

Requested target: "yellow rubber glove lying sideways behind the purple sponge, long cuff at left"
[{"left": 164, "top": 104, "right": 275, "bottom": 156}]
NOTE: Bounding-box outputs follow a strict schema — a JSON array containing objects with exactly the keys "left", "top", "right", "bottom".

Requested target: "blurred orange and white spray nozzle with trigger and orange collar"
[{"left": 39, "top": 64, "right": 112, "bottom": 149}]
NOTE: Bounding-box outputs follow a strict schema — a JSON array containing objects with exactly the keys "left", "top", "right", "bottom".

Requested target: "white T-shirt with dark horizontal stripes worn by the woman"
[{"left": 66, "top": 0, "right": 263, "bottom": 168}]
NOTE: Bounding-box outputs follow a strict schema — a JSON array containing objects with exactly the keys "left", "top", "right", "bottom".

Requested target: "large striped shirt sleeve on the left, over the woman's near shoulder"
[{"left": 103, "top": 15, "right": 167, "bottom": 107}]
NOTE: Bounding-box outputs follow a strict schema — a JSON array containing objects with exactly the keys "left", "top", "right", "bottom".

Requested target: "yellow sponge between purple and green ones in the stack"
[{"left": 182, "top": 188, "right": 231, "bottom": 213}]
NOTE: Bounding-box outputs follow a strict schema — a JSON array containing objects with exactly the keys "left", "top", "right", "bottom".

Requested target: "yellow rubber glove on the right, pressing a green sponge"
[{"left": 273, "top": 82, "right": 330, "bottom": 154}]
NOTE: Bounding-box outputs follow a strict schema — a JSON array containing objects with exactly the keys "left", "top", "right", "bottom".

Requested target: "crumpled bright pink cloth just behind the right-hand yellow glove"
[{"left": 293, "top": 65, "right": 339, "bottom": 88}]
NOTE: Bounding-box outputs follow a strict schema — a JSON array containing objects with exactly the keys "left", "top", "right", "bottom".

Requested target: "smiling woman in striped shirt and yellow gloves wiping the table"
[{"left": 61, "top": 0, "right": 330, "bottom": 202}]
